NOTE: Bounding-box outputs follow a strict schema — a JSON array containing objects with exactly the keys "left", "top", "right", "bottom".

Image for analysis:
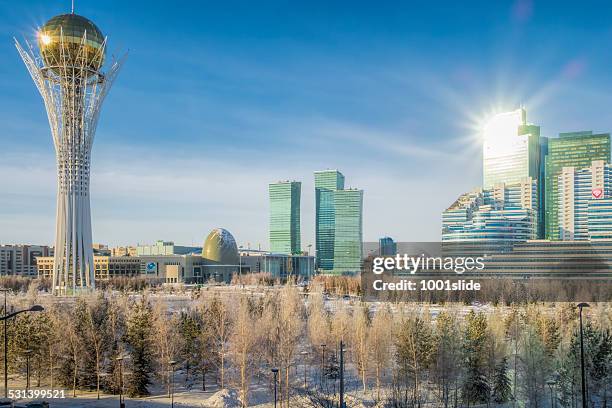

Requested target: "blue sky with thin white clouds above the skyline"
[{"left": 0, "top": 0, "right": 612, "bottom": 247}]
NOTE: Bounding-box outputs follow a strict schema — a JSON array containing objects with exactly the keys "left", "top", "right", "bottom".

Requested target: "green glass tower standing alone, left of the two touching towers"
[{"left": 268, "top": 181, "right": 302, "bottom": 254}]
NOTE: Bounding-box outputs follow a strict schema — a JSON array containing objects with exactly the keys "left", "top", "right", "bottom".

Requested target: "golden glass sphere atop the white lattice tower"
[{"left": 38, "top": 14, "right": 104, "bottom": 76}]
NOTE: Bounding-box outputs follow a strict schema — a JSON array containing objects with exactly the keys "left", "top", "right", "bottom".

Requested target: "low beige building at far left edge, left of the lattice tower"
[{"left": 0, "top": 245, "right": 53, "bottom": 277}]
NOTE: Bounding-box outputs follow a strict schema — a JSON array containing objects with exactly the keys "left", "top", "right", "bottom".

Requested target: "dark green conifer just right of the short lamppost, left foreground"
[{"left": 125, "top": 298, "right": 153, "bottom": 396}]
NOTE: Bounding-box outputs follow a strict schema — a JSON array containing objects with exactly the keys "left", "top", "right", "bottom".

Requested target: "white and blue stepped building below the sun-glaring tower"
[{"left": 442, "top": 177, "right": 538, "bottom": 251}]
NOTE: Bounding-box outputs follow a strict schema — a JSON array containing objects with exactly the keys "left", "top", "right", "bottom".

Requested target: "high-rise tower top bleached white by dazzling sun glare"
[{"left": 482, "top": 108, "right": 541, "bottom": 188}]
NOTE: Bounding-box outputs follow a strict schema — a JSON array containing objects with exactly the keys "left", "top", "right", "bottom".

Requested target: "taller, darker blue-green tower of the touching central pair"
[{"left": 315, "top": 170, "right": 344, "bottom": 271}]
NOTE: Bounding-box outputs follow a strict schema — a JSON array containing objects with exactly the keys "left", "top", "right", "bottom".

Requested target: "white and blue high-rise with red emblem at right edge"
[{"left": 558, "top": 160, "right": 612, "bottom": 241}]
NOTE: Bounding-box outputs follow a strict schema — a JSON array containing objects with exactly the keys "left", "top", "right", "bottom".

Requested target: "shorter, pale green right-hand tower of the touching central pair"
[{"left": 332, "top": 189, "right": 363, "bottom": 275}]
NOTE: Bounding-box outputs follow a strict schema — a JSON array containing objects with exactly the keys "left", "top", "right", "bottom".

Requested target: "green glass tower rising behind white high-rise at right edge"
[{"left": 544, "top": 131, "right": 610, "bottom": 240}]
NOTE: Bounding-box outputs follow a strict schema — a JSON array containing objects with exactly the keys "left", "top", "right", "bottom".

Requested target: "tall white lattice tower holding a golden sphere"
[{"left": 15, "top": 12, "right": 121, "bottom": 295}]
